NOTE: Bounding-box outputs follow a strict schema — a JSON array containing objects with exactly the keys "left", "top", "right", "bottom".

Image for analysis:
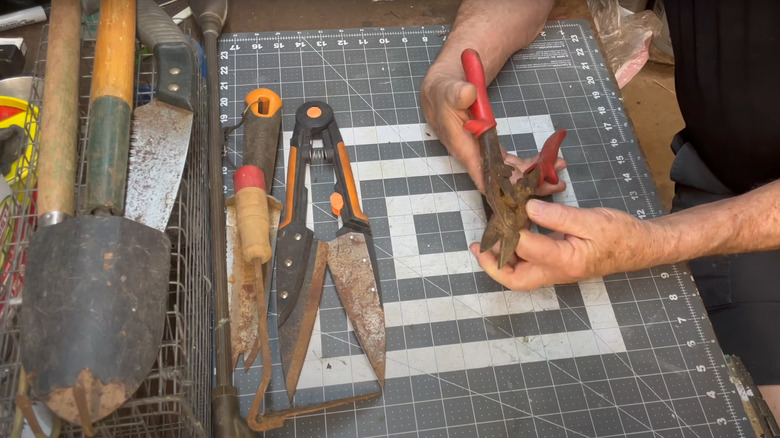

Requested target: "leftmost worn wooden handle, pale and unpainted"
[{"left": 38, "top": 0, "right": 81, "bottom": 221}]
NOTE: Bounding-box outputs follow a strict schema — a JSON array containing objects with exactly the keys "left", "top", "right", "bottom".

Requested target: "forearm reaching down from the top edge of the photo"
[{"left": 434, "top": 0, "right": 555, "bottom": 82}]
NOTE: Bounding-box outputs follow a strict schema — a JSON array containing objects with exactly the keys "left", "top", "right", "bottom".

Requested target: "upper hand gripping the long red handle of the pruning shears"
[{"left": 420, "top": 64, "right": 484, "bottom": 193}]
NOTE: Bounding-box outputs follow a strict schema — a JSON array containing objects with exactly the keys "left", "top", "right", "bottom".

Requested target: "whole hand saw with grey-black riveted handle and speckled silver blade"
[{"left": 125, "top": 0, "right": 198, "bottom": 231}]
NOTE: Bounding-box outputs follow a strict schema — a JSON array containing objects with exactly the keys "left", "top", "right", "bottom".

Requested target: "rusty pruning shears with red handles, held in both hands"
[{"left": 461, "top": 49, "right": 566, "bottom": 269}]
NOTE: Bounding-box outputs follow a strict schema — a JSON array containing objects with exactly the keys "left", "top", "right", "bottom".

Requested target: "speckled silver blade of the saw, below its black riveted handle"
[{"left": 125, "top": 99, "right": 193, "bottom": 231}]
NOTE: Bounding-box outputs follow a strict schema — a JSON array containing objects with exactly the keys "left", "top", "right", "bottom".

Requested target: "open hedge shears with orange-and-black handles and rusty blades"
[{"left": 276, "top": 101, "right": 386, "bottom": 402}]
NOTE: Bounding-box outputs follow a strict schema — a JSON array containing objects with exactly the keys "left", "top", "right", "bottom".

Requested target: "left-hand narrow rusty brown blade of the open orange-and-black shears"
[{"left": 277, "top": 240, "right": 328, "bottom": 403}]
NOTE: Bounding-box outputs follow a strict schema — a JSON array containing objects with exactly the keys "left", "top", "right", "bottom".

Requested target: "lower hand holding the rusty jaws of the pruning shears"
[{"left": 470, "top": 199, "right": 664, "bottom": 290}]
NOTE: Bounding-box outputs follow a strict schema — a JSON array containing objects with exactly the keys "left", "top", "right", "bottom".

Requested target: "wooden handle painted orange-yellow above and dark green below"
[{"left": 86, "top": 0, "right": 136, "bottom": 215}]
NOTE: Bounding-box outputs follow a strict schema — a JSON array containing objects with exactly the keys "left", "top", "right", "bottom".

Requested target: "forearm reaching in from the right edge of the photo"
[{"left": 648, "top": 180, "right": 780, "bottom": 265}]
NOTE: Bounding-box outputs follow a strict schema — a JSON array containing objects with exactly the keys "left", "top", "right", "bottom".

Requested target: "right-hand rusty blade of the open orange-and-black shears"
[{"left": 328, "top": 232, "right": 386, "bottom": 386}]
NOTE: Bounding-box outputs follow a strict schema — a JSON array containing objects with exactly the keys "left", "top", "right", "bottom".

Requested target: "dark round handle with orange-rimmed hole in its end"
[{"left": 242, "top": 88, "right": 282, "bottom": 190}]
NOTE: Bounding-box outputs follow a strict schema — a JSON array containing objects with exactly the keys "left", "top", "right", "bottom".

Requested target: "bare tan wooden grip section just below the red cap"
[{"left": 234, "top": 187, "right": 271, "bottom": 263}]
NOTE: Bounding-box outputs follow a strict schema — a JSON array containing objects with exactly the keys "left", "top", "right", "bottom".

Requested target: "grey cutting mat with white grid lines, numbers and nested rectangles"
[{"left": 219, "top": 20, "right": 750, "bottom": 437}]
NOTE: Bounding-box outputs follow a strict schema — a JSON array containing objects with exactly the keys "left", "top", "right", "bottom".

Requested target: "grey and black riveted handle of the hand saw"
[{"left": 136, "top": 0, "right": 197, "bottom": 111}]
